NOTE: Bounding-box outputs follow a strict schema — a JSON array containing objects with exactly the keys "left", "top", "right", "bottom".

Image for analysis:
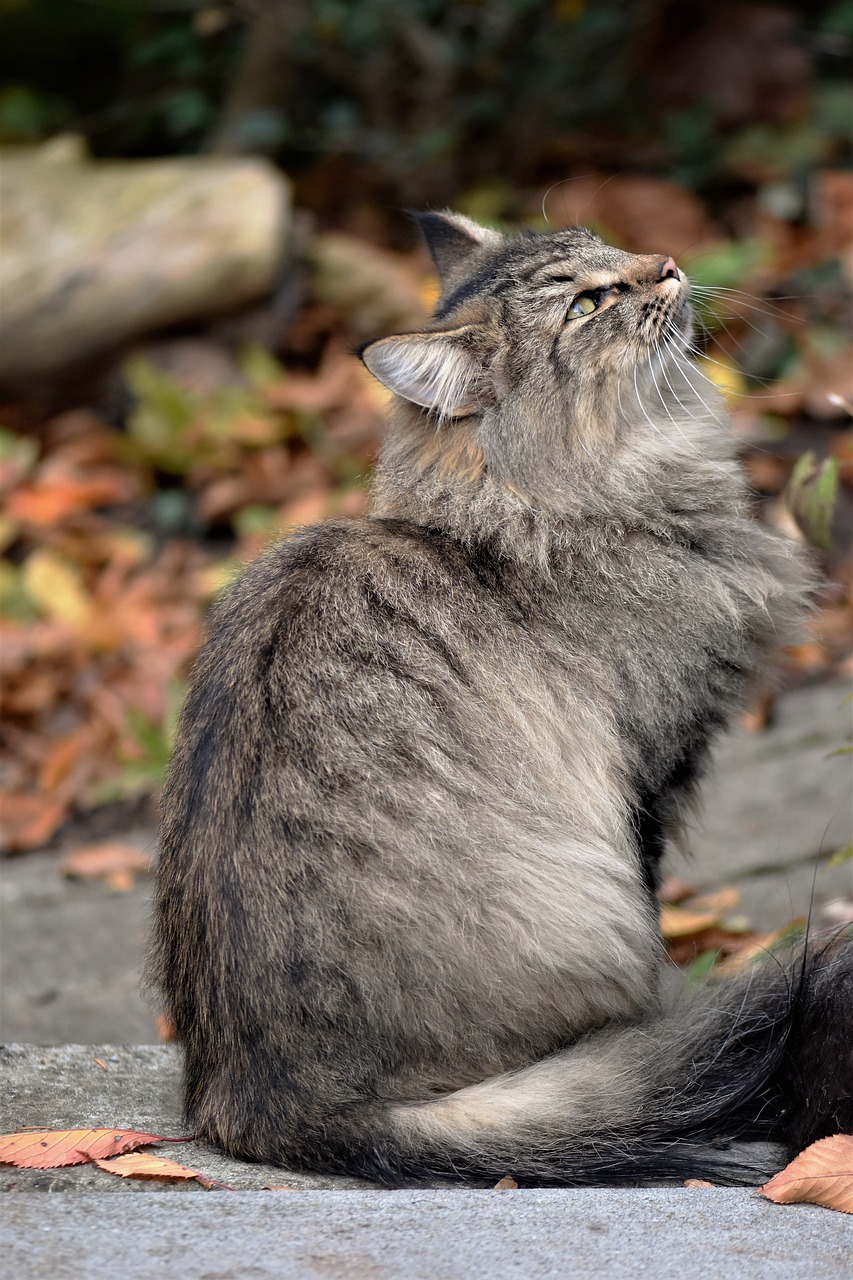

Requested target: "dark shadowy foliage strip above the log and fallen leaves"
[{"left": 0, "top": 0, "right": 853, "bottom": 209}]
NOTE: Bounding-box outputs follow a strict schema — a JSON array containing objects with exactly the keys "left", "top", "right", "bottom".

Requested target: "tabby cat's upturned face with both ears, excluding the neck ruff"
[{"left": 361, "top": 214, "right": 690, "bottom": 421}]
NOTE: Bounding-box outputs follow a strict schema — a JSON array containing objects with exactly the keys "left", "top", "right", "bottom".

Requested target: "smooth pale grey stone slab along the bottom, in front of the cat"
[{"left": 3, "top": 1174, "right": 853, "bottom": 1280}]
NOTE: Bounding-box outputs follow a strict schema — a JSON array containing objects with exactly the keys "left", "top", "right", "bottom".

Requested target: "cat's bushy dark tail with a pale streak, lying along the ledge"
[{"left": 373, "top": 938, "right": 853, "bottom": 1185}]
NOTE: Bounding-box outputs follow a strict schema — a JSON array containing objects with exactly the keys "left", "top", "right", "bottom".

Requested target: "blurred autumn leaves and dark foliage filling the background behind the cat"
[{"left": 0, "top": 0, "right": 853, "bottom": 851}]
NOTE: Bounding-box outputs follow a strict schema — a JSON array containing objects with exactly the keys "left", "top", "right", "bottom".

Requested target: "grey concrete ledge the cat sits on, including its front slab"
[{"left": 0, "top": 1044, "right": 853, "bottom": 1280}]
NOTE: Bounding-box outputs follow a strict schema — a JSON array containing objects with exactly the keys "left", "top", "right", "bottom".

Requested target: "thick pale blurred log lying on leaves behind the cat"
[{"left": 0, "top": 140, "right": 291, "bottom": 384}]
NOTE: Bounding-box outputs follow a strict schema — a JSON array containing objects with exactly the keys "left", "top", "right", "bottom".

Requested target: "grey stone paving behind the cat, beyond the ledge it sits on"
[{"left": 0, "top": 684, "right": 853, "bottom": 1044}]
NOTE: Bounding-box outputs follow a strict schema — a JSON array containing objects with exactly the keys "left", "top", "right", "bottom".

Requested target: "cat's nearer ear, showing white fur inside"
[{"left": 360, "top": 329, "right": 493, "bottom": 417}]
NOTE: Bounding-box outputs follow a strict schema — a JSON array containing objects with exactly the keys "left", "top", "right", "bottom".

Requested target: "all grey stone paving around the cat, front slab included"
[{"left": 0, "top": 684, "right": 853, "bottom": 1280}]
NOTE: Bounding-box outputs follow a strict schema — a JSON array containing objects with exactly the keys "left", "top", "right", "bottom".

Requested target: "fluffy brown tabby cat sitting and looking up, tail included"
[{"left": 151, "top": 212, "right": 853, "bottom": 1185}]
